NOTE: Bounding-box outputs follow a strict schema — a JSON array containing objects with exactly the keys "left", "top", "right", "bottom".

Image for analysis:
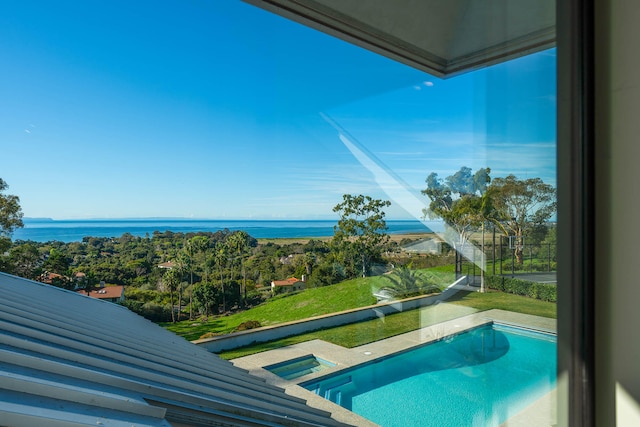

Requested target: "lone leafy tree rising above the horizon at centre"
[{"left": 332, "top": 194, "right": 391, "bottom": 277}]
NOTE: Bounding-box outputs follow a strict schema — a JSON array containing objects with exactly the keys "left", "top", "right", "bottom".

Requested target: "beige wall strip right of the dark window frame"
[{"left": 595, "top": 0, "right": 640, "bottom": 426}]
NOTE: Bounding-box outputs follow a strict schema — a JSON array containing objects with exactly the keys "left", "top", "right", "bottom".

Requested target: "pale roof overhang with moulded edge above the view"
[{"left": 245, "top": 0, "right": 555, "bottom": 77}]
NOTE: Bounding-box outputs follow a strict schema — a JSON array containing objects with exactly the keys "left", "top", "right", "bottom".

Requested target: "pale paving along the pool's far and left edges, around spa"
[{"left": 231, "top": 309, "right": 557, "bottom": 427}]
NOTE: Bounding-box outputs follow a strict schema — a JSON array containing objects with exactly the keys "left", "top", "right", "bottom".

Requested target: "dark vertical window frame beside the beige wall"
[{"left": 556, "top": 0, "right": 595, "bottom": 427}]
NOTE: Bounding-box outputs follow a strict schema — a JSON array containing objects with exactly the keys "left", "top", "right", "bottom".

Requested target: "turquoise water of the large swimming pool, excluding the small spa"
[{"left": 301, "top": 324, "right": 556, "bottom": 427}]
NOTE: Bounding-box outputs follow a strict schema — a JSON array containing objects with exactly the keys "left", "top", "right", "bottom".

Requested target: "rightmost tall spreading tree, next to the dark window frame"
[{"left": 491, "top": 175, "right": 557, "bottom": 264}]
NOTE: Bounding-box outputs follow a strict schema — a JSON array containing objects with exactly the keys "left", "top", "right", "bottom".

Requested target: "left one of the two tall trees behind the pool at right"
[{"left": 422, "top": 166, "right": 491, "bottom": 272}]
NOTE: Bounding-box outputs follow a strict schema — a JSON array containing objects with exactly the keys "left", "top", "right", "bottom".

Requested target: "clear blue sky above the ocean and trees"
[{"left": 0, "top": 0, "right": 556, "bottom": 219}]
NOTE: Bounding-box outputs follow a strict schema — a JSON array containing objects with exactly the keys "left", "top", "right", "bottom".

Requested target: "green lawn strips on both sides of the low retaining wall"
[{"left": 162, "top": 267, "right": 556, "bottom": 359}]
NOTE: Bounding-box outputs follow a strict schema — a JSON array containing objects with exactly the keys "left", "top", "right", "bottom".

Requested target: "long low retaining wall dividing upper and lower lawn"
[{"left": 193, "top": 276, "right": 467, "bottom": 353}]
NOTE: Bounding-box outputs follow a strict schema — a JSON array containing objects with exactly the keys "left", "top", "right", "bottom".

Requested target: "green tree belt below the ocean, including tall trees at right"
[{"left": 0, "top": 167, "right": 556, "bottom": 321}]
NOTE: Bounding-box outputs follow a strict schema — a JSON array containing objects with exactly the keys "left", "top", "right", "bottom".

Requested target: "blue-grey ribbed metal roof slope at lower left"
[{"left": 0, "top": 273, "right": 345, "bottom": 426}]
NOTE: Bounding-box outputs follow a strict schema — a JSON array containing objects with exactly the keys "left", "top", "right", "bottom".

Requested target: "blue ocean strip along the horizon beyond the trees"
[{"left": 12, "top": 218, "right": 438, "bottom": 243}]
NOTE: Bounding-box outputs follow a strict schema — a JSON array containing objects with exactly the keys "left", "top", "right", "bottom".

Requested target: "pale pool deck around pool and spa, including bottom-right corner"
[{"left": 232, "top": 310, "right": 556, "bottom": 427}]
